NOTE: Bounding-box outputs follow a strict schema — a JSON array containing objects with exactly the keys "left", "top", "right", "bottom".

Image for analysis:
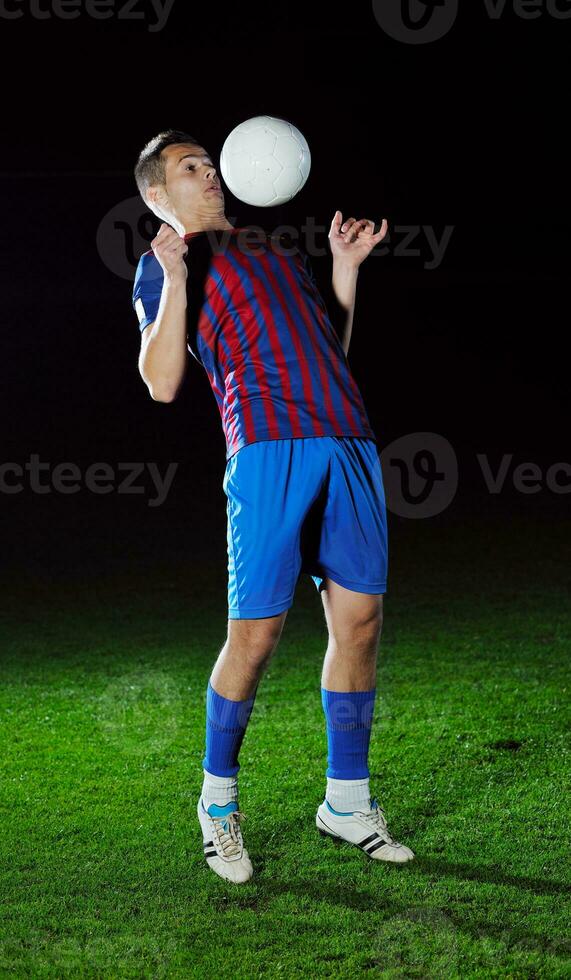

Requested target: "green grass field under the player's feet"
[{"left": 0, "top": 502, "right": 571, "bottom": 980}]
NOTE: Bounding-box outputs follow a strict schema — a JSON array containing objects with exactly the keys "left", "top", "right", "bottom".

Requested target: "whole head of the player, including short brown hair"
[{"left": 135, "top": 129, "right": 226, "bottom": 231}]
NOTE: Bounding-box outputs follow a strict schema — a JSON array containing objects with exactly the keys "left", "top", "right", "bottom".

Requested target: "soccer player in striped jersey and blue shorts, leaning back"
[{"left": 133, "top": 130, "right": 414, "bottom": 882}]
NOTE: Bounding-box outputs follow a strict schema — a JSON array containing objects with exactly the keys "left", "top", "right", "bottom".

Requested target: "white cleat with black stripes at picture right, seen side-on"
[{"left": 315, "top": 799, "right": 414, "bottom": 864}]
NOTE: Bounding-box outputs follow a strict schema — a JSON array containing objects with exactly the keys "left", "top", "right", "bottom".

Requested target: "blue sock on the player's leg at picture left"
[{"left": 202, "top": 681, "right": 257, "bottom": 776}]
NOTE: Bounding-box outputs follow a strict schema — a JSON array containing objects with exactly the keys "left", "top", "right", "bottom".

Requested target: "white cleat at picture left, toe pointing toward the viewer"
[{"left": 197, "top": 796, "right": 254, "bottom": 882}]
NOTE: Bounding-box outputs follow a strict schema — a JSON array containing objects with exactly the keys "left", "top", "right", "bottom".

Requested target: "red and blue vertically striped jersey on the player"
[{"left": 133, "top": 228, "right": 377, "bottom": 460}]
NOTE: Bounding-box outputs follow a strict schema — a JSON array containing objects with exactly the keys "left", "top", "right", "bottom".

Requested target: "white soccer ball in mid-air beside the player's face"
[{"left": 220, "top": 116, "right": 311, "bottom": 208}]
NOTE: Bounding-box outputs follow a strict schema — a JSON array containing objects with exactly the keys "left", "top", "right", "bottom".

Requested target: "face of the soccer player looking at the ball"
[{"left": 150, "top": 143, "right": 224, "bottom": 222}]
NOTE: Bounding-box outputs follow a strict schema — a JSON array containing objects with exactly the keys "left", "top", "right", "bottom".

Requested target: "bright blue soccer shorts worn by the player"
[{"left": 223, "top": 436, "right": 388, "bottom": 619}]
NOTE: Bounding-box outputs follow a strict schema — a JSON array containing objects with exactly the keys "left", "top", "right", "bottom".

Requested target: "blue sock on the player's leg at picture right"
[{"left": 321, "top": 687, "right": 377, "bottom": 779}]
